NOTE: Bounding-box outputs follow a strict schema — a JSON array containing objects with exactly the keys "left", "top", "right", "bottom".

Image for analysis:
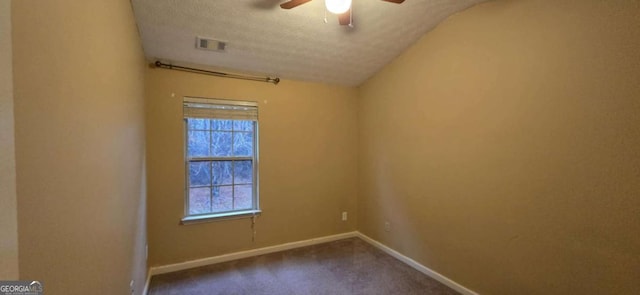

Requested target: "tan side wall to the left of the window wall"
[{"left": 12, "top": 0, "right": 146, "bottom": 294}]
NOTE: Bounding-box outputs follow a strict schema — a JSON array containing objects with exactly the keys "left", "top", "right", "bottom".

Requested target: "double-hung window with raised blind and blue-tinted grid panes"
[{"left": 183, "top": 98, "right": 259, "bottom": 222}]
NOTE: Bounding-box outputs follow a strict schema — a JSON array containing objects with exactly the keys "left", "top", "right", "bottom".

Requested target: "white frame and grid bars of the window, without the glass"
[{"left": 180, "top": 97, "right": 262, "bottom": 224}]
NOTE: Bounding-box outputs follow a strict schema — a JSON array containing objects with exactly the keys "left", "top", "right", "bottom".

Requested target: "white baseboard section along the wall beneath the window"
[{"left": 149, "top": 231, "right": 358, "bottom": 276}]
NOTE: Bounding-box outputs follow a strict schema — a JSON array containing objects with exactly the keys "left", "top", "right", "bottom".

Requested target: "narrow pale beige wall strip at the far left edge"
[{"left": 0, "top": 0, "right": 18, "bottom": 280}]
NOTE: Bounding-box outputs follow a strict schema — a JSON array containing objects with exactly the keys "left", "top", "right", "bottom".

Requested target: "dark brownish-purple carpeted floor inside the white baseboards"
[{"left": 149, "top": 238, "right": 458, "bottom": 295}]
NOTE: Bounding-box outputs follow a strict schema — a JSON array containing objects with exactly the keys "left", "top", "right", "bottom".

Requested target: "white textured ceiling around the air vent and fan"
[{"left": 132, "top": 0, "right": 485, "bottom": 86}]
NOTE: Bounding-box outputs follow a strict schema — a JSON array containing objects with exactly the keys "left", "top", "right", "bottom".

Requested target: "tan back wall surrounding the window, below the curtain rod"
[{"left": 146, "top": 69, "right": 357, "bottom": 265}]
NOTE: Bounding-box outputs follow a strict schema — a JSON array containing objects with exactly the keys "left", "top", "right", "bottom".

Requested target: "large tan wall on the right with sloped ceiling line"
[{"left": 358, "top": 0, "right": 640, "bottom": 294}]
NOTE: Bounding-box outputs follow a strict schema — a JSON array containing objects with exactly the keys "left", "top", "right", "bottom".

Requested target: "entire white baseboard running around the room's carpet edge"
[{"left": 142, "top": 231, "right": 478, "bottom": 295}]
